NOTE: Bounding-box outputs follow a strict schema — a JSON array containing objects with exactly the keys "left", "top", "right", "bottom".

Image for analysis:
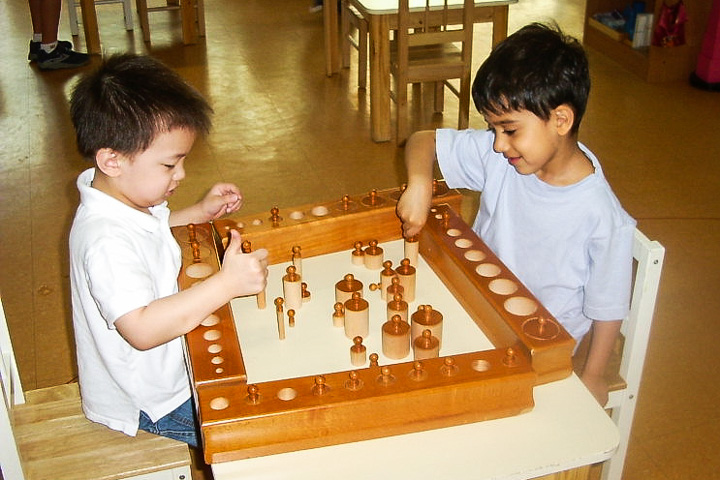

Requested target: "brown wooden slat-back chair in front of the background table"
[{"left": 390, "top": 0, "right": 474, "bottom": 144}]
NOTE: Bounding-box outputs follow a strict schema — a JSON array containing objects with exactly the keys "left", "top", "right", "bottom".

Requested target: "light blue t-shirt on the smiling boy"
[{"left": 436, "top": 129, "right": 635, "bottom": 342}]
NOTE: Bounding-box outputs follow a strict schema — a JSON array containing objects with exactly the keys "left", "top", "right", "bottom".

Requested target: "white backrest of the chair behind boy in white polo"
[{"left": 0, "top": 298, "right": 25, "bottom": 480}]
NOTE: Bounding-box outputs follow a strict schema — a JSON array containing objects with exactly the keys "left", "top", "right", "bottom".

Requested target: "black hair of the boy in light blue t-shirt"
[{"left": 472, "top": 23, "right": 590, "bottom": 133}]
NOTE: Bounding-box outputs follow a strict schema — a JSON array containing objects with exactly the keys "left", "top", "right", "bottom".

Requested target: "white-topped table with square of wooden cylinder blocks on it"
[{"left": 174, "top": 185, "right": 618, "bottom": 480}]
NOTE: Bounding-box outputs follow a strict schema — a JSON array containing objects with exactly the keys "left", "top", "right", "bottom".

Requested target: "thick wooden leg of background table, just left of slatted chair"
[{"left": 370, "top": 15, "right": 391, "bottom": 142}]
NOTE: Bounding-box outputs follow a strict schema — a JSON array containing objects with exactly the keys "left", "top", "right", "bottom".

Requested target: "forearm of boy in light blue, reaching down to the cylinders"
[{"left": 396, "top": 130, "right": 436, "bottom": 238}]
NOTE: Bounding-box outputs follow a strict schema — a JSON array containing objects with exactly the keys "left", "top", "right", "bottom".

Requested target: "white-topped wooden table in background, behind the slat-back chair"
[{"left": 323, "top": 0, "right": 518, "bottom": 142}]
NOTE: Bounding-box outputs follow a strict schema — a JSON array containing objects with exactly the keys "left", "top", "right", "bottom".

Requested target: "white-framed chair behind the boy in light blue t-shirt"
[{"left": 574, "top": 230, "right": 665, "bottom": 480}]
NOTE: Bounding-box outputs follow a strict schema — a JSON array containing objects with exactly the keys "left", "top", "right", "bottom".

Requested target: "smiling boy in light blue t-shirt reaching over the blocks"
[{"left": 397, "top": 24, "right": 635, "bottom": 405}]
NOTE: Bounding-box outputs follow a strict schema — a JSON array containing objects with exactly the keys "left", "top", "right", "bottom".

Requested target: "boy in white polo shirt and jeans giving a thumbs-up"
[{"left": 70, "top": 55, "right": 267, "bottom": 446}]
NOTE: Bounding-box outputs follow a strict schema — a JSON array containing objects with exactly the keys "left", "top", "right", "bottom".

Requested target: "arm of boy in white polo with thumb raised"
[{"left": 115, "top": 230, "right": 267, "bottom": 350}]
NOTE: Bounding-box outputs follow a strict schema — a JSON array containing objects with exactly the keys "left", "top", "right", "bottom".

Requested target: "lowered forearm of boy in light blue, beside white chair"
[{"left": 581, "top": 320, "right": 622, "bottom": 406}]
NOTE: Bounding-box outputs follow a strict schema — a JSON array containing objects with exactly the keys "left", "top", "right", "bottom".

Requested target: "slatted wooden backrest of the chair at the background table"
[{"left": 397, "top": 0, "right": 475, "bottom": 79}]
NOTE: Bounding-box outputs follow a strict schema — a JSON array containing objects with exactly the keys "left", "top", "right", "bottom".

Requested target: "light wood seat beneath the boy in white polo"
[{"left": 12, "top": 383, "right": 190, "bottom": 480}]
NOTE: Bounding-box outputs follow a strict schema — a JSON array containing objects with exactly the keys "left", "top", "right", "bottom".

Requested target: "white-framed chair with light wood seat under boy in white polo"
[{"left": 0, "top": 294, "right": 192, "bottom": 480}]
